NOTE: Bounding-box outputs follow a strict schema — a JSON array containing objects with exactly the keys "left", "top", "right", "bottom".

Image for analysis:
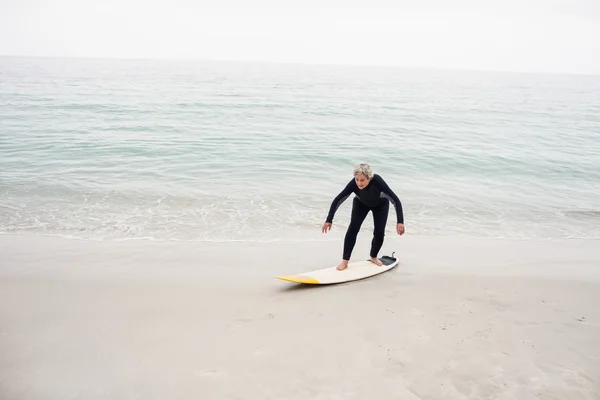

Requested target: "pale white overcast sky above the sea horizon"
[{"left": 0, "top": 0, "right": 600, "bottom": 74}]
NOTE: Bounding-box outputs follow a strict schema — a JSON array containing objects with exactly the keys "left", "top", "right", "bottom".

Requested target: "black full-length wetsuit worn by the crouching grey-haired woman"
[{"left": 325, "top": 174, "right": 404, "bottom": 260}]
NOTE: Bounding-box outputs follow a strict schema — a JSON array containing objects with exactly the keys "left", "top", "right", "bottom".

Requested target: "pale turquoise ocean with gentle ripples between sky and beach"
[{"left": 0, "top": 57, "right": 600, "bottom": 242}]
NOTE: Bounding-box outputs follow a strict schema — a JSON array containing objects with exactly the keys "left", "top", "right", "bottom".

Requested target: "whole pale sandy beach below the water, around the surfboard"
[{"left": 0, "top": 235, "right": 600, "bottom": 400}]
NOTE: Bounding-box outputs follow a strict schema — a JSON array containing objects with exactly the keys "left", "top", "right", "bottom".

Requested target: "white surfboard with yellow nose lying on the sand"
[{"left": 276, "top": 253, "right": 398, "bottom": 285}]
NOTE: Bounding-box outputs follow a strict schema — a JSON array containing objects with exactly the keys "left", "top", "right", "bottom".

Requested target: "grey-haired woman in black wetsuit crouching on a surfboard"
[{"left": 322, "top": 163, "right": 404, "bottom": 271}]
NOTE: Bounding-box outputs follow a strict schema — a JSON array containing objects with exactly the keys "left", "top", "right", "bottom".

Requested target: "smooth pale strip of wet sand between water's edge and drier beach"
[{"left": 0, "top": 232, "right": 600, "bottom": 284}]
